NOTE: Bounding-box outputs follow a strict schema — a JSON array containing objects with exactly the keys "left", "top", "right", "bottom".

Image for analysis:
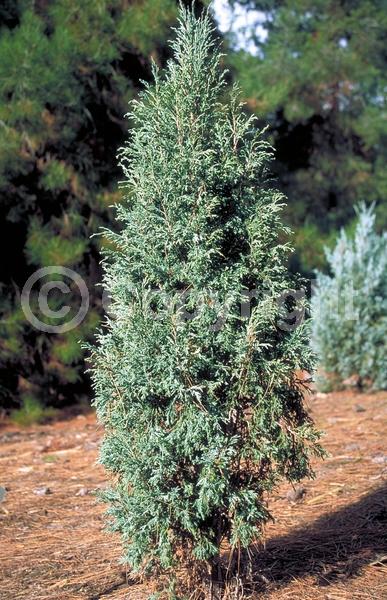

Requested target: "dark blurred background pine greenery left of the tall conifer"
[{"left": 0, "top": 0, "right": 206, "bottom": 407}]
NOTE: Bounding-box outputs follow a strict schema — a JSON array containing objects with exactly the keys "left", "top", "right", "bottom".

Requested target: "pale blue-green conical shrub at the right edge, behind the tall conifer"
[{"left": 312, "top": 206, "right": 387, "bottom": 389}]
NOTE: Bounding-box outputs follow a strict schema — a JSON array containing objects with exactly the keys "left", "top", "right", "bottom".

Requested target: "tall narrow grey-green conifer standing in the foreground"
[{"left": 92, "top": 4, "right": 321, "bottom": 592}]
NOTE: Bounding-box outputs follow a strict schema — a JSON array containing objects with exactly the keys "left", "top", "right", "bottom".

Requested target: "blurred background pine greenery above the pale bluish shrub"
[{"left": 223, "top": 0, "right": 387, "bottom": 273}]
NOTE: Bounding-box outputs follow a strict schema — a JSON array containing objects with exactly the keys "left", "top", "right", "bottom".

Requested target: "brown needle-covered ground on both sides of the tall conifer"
[{"left": 0, "top": 391, "right": 387, "bottom": 600}]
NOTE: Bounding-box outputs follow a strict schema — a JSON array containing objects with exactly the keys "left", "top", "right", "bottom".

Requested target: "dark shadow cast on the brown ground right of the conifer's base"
[{"left": 253, "top": 485, "right": 387, "bottom": 591}]
